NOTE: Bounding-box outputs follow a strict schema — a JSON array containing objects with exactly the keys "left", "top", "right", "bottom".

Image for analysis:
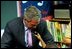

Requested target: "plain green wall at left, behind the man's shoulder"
[{"left": 1, "top": 1, "right": 17, "bottom": 36}]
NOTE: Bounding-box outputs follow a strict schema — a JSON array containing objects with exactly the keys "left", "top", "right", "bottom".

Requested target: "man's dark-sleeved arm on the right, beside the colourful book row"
[{"left": 36, "top": 20, "right": 57, "bottom": 48}]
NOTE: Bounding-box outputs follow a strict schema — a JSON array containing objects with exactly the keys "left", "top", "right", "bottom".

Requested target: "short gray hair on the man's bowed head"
[{"left": 24, "top": 6, "right": 41, "bottom": 21}]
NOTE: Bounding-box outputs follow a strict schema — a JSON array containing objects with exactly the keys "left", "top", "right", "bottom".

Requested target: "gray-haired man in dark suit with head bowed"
[{"left": 1, "top": 6, "right": 57, "bottom": 48}]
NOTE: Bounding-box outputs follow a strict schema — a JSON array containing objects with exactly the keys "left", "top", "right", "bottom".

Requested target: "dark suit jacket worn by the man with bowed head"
[{"left": 1, "top": 17, "right": 56, "bottom": 48}]
